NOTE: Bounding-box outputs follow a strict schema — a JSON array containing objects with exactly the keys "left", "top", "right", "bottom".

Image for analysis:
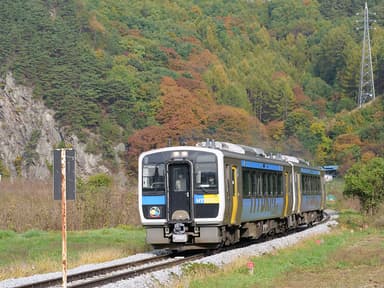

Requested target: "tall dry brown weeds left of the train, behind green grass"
[{"left": 0, "top": 179, "right": 139, "bottom": 232}]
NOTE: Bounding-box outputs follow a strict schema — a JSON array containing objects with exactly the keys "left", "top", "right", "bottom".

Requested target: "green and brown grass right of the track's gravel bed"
[{"left": 173, "top": 229, "right": 384, "bottom": 288}]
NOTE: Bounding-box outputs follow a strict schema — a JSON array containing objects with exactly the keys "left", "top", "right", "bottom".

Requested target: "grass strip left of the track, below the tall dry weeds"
[{"left": 0, "top": 226, "right": 149, "bottom": 280}]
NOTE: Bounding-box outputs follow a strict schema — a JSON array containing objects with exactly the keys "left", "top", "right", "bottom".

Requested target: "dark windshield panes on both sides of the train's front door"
[{"left": 142, "top": 151, "right": 218, "bottom": 194}]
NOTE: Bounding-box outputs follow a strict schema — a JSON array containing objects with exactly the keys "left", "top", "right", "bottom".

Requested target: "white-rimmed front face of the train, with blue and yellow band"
[{"left": 138, "top": 146, "right": 225, "bottom": 249}]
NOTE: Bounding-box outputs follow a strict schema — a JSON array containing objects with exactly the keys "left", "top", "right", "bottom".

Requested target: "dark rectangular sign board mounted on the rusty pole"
[{"left": 53, "top": 149, "right": 76, "bottom": 200}]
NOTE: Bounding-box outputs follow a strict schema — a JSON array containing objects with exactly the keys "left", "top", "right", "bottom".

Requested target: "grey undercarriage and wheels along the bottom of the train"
[{"left": 146, "top": 210, "right": 323, "bottom": 250}]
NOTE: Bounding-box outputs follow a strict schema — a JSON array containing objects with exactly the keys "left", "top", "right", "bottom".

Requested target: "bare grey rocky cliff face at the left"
[{"left": 0, "top": 73, "right": 109, "bottom": 179}]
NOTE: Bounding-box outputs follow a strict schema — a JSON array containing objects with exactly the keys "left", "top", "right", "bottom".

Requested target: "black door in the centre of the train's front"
[{"left": 167, "top": 162, "right": 192, "bottom": 220}]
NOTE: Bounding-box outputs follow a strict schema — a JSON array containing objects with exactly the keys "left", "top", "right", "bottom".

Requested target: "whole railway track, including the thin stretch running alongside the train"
[{"left": 9, "top": 213, "right": 330, "bottom": 288}]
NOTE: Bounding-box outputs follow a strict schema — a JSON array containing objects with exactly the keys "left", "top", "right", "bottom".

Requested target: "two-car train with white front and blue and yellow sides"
[{"left": 138, "top": 140, "right": 326, "bottom": 250}]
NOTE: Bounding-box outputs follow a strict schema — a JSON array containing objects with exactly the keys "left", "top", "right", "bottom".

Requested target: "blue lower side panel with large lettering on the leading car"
[{"left": 241, "top": 197, "right": 284, "bottom": 221}]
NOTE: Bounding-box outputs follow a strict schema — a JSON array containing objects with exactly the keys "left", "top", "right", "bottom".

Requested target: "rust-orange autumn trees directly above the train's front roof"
[{"left": 128, "top": 77, "right": 256, "bottom": 169}]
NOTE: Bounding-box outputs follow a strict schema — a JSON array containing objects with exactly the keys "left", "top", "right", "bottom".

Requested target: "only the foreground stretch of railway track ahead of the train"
[{"left": 15, "top": 254, "right": 204, "bottom": 288}]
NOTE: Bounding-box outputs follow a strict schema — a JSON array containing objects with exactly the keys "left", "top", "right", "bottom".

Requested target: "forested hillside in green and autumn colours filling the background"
[{"left": 0, "top": 0, "right": 384, "bottom": 175}]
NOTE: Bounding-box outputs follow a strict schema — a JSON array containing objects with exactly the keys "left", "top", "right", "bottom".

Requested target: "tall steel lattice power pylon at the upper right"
[{"left": 358, "top": 2, "right": 375, "bottom": 107}]
